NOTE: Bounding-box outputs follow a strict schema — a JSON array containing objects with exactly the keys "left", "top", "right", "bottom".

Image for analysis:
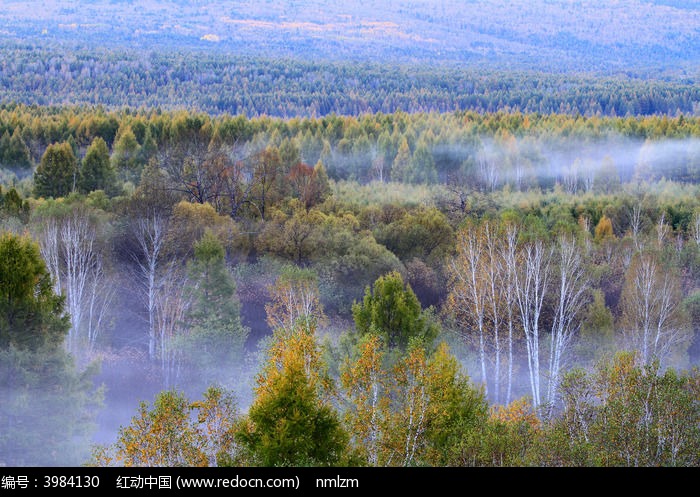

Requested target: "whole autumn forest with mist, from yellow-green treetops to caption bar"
[{"left": 0, "top": 103, "right": 700, "bottom": 466}]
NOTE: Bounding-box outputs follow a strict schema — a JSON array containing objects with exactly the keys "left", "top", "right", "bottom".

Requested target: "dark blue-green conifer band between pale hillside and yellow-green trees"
[{"left": 0, "top": 44, "right": 700, "bottom": 119}]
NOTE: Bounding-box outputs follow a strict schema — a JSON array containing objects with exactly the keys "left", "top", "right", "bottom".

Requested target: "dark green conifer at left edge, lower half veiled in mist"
[{"left": 0, "top": 233, "right": 103, "bottom": 466}]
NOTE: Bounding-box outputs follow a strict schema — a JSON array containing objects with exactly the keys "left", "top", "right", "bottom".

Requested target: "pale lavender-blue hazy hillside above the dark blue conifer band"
[{"left": 0, "top": 0, "right": 700, "bottom": 76}]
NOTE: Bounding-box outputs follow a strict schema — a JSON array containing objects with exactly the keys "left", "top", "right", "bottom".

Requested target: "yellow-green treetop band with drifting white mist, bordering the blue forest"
[{"left": 0, "top": 104, "right": 700, "bottom": 193}]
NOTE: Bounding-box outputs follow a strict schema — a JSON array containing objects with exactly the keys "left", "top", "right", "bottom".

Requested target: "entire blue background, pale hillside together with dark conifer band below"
[{"left": 0, "top": 0, "right": 700, "bottom": 118}]
